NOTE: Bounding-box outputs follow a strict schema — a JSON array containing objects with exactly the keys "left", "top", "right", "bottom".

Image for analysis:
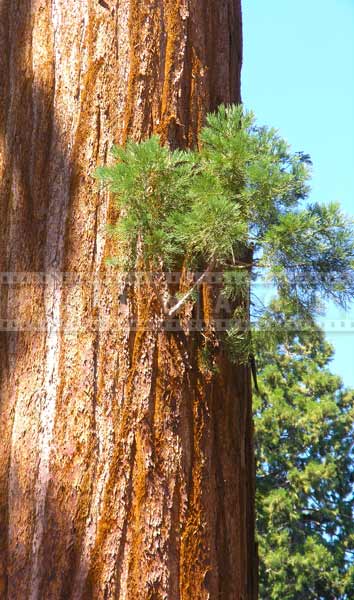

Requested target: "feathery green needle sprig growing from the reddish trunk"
[{"left": 96, "top": 106, "right": 354, "bottom": 356}]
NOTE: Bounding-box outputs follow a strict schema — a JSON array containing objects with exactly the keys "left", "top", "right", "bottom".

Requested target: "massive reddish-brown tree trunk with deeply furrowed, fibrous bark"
[{"left": 0, "top": 0, "right": 257, "bottom": 600}]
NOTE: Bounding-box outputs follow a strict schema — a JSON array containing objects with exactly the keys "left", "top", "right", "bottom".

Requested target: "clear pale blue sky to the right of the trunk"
[{"left": 242, "top": 0, "right": 354, "bottom": 386}]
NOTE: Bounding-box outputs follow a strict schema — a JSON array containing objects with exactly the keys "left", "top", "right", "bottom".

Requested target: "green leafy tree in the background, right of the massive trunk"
[{"left": 254, "top": 303, "right": 354, "bottom": 600}]
